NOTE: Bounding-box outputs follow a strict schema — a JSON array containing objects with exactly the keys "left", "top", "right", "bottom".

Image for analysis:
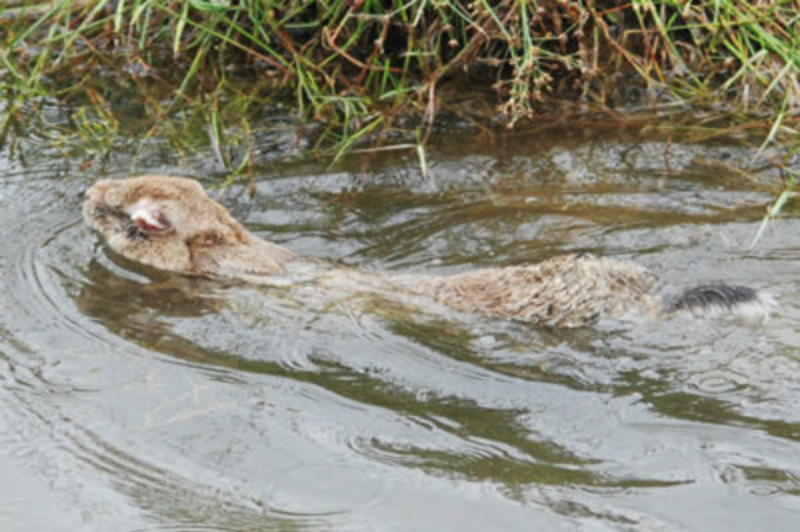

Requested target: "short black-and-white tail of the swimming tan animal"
[{"left": 666, "top": 284, "right": 776, "bottom": 321}]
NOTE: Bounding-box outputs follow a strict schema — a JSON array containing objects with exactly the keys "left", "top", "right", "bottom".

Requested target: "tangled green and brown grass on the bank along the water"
[{"left": 0, "top": 0, "right": 800, "bottom": 180}]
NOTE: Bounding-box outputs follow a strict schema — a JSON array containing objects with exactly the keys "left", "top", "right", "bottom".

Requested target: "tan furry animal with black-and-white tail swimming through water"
[{"left": 83, "top": 175, "right": 772, "bottom": 327}]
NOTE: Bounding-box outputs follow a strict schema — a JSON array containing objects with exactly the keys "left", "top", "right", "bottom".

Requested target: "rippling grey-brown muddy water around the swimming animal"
[{"left": 0, "top": 131, "right": 800, "bottom": 531}]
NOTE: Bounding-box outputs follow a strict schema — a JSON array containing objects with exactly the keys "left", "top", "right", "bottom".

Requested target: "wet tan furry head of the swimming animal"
[{"left": 83, "top": 175, "right": 248, "bottom": 275}]
